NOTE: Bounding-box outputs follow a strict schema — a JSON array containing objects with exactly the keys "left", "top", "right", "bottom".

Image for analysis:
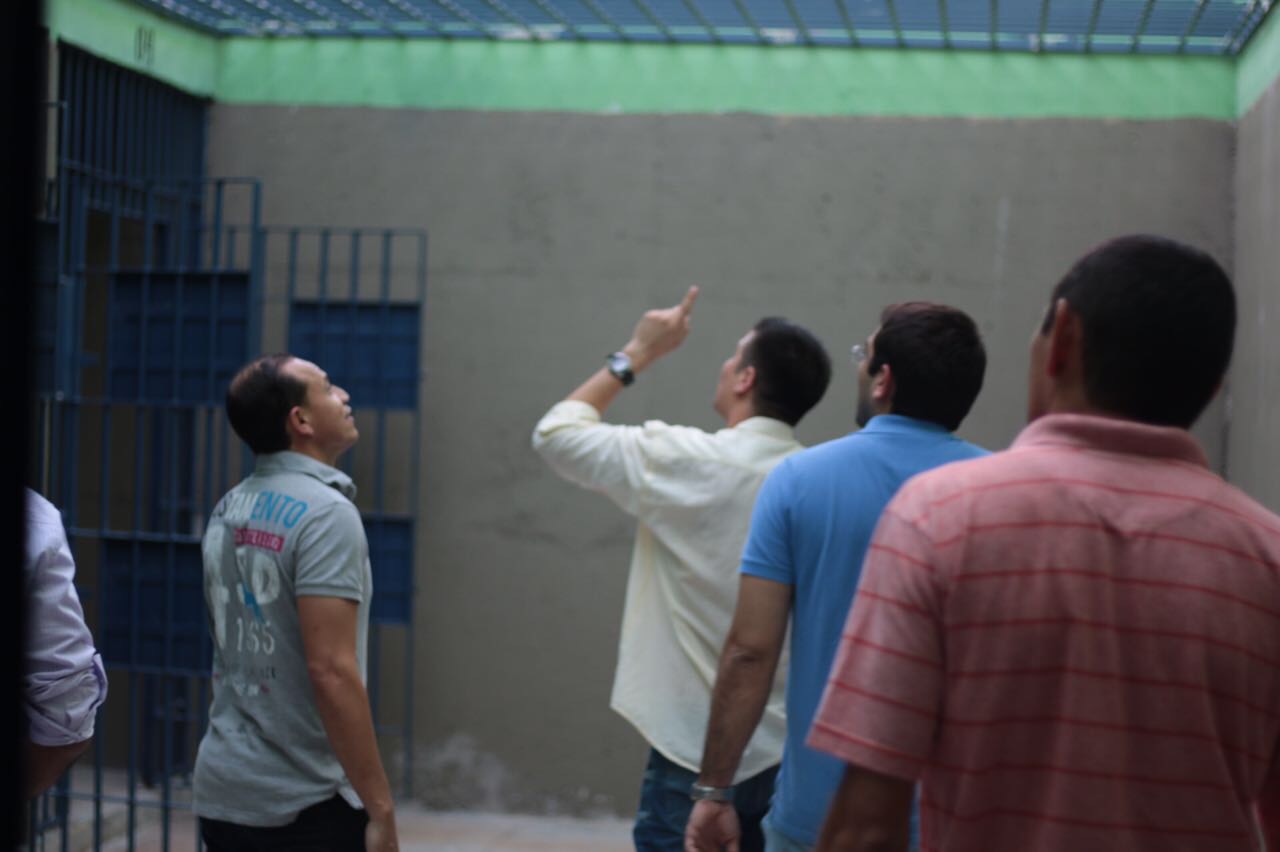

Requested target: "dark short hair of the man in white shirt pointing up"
[{"left": 739, "top": 316, "right": 831, "bottom": 426}]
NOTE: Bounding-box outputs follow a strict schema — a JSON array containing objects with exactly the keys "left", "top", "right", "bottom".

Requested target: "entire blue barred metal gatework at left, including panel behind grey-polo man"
[{"left": 28, "top": 45, "right": 426, "bottom": 849}]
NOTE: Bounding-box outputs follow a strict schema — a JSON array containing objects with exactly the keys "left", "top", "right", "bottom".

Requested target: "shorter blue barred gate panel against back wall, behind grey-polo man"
[{"left": 265, "top": 226, "right": 426, "bottom": 794}]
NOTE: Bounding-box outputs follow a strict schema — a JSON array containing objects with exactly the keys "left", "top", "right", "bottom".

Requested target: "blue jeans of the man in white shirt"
[{"left": 631, "top": 748, "right": 778, "bottom": 852}]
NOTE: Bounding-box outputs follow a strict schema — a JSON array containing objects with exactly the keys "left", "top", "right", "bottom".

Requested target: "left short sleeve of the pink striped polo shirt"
[{"left": 808, "top": 485, "right": 946, "bottom": 779}]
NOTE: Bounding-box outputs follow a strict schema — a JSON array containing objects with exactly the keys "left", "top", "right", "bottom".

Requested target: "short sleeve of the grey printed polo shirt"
[{"left": 293, "top": 503, "right": 369, "bottom": 601}]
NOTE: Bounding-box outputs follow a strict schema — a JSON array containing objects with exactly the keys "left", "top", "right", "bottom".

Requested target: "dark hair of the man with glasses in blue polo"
[{"left": 867, "top": 302, "right": 987, "bottom": 432}]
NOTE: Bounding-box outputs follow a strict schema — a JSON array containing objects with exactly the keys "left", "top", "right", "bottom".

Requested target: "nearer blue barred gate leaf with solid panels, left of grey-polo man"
[{"left": 35, "top": 172, "right": 261, "bottom": 848}]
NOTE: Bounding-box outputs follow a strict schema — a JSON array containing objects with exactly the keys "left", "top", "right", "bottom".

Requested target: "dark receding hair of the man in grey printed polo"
[{"left": 227, "top": 352, "right": 307, "bottom": 455}]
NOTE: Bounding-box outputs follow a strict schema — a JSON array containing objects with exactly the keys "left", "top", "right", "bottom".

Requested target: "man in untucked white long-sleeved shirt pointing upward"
[{"left": 532, "top": 287, "right": 831, "bottom": 852}]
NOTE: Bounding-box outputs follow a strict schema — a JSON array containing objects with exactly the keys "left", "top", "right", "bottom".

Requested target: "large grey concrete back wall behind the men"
[{"left": 209, "top": 105, "right": 1228, "bottom": 812}]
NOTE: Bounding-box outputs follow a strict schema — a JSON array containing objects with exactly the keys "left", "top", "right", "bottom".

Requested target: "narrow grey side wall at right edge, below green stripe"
[{"left": 1228, "top": 79, "right": 1280, "bottom": 512}]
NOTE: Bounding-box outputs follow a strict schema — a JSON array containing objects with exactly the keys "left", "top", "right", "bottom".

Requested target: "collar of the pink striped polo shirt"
[{"left": 1012, "top": 414, "right": 1208, "bottom": 468}]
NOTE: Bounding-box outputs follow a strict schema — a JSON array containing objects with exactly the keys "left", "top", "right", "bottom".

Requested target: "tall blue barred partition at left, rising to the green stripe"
[{"left": 28, "top": 43, "right": 260, "bottom": 849}]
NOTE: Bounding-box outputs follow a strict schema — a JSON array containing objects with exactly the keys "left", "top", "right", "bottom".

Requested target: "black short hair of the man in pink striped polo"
[{"left": 1041, "top": 234, "right": 1235, "bottom": 429}]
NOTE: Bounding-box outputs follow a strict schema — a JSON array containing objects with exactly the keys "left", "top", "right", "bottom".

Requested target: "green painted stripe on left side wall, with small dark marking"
[{"left": 45, "top": 0, "right": 221, "bottom": 97}]
